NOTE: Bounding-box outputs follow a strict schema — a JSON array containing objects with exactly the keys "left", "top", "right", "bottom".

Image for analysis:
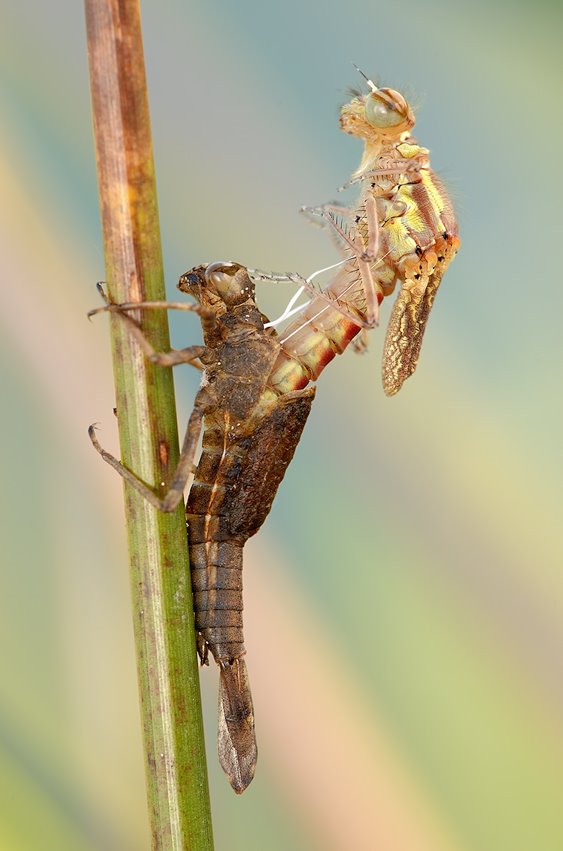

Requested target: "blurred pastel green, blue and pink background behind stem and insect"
[{"left": 0, "top": 0, "right": 563, "bottom": 851}]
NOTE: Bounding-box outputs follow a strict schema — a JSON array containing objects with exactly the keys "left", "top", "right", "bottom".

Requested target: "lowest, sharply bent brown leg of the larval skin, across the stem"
[{"left": 88, "top": 388, "right": 209, "bottom": 511}]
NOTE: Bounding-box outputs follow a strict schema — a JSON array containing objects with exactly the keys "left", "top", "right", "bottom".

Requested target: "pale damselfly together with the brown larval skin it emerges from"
[{"left": 90, "top": 73, "right": 459, "bottom": 793}]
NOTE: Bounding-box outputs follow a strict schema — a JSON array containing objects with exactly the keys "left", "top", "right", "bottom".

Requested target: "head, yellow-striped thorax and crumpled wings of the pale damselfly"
[{"left": 340, "top": 78, "right": 459, "bottom": 395}]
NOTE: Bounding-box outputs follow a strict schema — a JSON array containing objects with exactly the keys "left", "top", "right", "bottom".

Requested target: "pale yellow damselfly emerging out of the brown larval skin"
[{"left": 256, "top": 72, "right": 459, "bottom": 396}]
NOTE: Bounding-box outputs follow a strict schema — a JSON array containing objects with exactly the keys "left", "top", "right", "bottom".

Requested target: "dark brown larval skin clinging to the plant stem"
[{"left": 90, "top": 263, "right": 315, "bottom": 793}]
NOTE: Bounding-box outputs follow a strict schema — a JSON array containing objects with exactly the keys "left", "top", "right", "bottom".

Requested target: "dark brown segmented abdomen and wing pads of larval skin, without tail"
[{"left": 186, "top": 388, "right": 314, "bottom": 663}]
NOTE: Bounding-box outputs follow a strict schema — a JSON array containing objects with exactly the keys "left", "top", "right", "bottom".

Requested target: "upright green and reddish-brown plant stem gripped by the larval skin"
[{"left": 85, "top": 0, "right": 213, "bottom": 851}]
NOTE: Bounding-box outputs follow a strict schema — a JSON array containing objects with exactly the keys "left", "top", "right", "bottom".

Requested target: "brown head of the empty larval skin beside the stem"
[{"left": 178, "top": 261, "right": 255, "bottom": 307}]
